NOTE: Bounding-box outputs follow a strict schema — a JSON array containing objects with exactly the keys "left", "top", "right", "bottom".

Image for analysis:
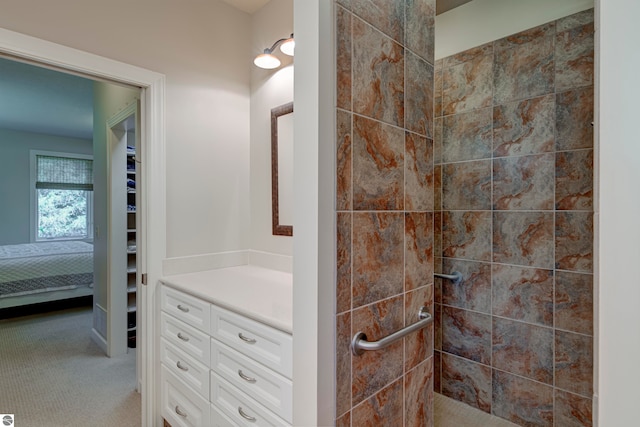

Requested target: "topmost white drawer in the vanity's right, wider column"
[{"left": 211, "top": 306, "right": 293, "bottom": 378}]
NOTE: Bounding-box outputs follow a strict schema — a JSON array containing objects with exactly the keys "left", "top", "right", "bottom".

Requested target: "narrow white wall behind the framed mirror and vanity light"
[{"left": 251, "top": 0, "right": 295, "bottom": 256}]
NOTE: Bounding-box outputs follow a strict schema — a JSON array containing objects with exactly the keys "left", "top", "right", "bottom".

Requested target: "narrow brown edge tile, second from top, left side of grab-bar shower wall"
[{"left": 336, "top": 110, "right": 352, "bottom": 211}]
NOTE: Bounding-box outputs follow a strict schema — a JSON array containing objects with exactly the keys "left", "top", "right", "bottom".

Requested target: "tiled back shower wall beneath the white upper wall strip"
[{"left": 434, "top": 10, "right": 594, "bottom": 427}]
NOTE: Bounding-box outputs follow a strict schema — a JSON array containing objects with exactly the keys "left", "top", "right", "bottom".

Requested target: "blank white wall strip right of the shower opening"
[{"left": 594, "top": 0, "right": 640, "bottom": 427}]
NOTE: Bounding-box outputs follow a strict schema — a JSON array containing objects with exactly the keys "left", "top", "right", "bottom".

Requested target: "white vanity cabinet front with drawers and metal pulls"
[{"left": 160, "top": 270, "right": 293, "bottom": 427}]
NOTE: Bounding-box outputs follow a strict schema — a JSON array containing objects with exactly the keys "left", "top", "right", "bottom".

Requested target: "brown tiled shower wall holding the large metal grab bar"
[{"left": 335, "top": 0, "right": 435, "bottom": 426}]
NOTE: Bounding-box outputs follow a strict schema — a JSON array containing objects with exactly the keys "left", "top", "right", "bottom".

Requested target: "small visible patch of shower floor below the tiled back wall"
[{"left": 433, "top": 393, "right": 518, "bottom": 427}]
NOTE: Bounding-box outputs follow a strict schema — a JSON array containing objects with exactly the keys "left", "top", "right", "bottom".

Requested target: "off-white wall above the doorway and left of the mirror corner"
[{"left": 0, "top": 0, "right": 252, "bottom": 257}]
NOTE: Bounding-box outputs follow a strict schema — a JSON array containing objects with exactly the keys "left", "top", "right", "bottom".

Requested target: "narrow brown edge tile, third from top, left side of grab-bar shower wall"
[{"left": 336, "top": 212, "right": 352, "bottom": 313}]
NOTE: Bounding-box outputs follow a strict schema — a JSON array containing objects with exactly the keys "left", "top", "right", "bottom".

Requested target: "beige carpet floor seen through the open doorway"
[{"left": 0, "top": 308, "right": 140, "bottom": 427}]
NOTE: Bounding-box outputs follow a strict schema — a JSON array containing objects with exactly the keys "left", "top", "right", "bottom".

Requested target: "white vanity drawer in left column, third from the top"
[{"left": 160, "top": 338, "right": 209, "bottom": 400}]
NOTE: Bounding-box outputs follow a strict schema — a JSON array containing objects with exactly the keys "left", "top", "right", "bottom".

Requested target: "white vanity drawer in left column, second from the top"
[{"left": 160, "top": 312, "right": 211, "bottom": 365}]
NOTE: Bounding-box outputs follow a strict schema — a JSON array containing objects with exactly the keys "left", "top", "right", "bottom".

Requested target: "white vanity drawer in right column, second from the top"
[{"left": 211, "top": 339, "right": 293, "bottom": 422}]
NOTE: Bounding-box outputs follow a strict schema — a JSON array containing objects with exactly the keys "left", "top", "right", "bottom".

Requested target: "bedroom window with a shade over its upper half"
[{"left": 31, "top": 151, "right": 93, "bottom": 241}]
